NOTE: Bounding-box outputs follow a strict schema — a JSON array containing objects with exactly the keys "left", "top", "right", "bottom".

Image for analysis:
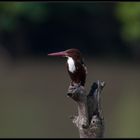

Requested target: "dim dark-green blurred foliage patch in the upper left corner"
[{"left": 0, "top": 2, "right": 47, "bottom": 31}]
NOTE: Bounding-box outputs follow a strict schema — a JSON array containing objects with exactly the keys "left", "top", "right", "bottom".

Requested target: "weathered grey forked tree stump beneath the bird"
[{"left": 67, "top": 81, "right": 105, "bottom": 138}]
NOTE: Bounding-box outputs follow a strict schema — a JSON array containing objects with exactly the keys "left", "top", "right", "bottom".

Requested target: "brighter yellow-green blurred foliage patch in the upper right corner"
[{"left": 116, "top": 2, "right": 140, "bottom": 42}]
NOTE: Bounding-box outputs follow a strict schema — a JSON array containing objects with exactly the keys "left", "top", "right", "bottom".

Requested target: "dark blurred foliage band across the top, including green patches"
[{"left": 0, "top": 2, "right": 140, "bottom": 58}]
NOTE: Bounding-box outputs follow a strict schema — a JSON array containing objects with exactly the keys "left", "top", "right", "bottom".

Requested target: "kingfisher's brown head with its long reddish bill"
[{"left": 48, "top": 48, "right": 82, "bottom": 59}]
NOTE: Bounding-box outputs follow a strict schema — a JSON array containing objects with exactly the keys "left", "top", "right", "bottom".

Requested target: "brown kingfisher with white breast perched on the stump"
[{"left": 48, "top": 48, "right": 87, "bottom": 87}]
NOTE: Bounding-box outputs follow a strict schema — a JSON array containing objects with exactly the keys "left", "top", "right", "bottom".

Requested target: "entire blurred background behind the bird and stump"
[{"left": 0, "top": 2, "right": 140, "bottom": 138}]
